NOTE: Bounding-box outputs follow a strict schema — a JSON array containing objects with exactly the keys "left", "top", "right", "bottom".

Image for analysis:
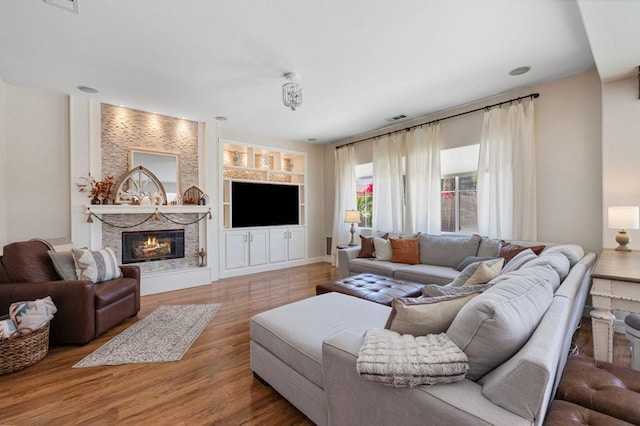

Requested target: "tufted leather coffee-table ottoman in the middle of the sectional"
[{"left": 316, "top": 274, "right": 424, "bottom": 306}]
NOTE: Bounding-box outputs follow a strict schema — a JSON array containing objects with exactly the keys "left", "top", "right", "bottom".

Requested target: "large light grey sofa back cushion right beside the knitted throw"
[{"left": 447, "top": 268, "right": 557, "bottom": 380}]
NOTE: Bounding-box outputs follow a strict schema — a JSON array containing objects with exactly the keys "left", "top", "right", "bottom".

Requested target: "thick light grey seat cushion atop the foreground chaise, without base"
[{"left": 249, "top": 293, "right": 391, "bottom": 388}]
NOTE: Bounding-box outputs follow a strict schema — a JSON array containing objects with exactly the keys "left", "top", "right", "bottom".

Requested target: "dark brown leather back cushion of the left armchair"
[{"left": 2, "top": 241, "right": 60, "bottom": 282}]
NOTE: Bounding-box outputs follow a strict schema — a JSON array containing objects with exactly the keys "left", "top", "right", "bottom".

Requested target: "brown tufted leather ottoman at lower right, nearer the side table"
[{"left": 556, "top": 356, "right": 640, "bottom": 425}]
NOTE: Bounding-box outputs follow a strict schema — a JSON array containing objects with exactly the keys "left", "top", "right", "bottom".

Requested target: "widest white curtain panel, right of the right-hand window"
[{"left": 477, "top": 101, "right": 537, "bottom": 241}]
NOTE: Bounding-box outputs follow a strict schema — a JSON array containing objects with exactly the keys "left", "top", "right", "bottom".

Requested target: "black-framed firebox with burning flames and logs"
[{"left": 122, "top": 229, "right": 184, "bottom": 264}]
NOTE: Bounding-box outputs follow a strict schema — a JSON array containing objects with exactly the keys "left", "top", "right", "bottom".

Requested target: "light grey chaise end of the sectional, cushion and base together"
[{"left": 249, "top": 293, "right": 391, "bottom": 425}]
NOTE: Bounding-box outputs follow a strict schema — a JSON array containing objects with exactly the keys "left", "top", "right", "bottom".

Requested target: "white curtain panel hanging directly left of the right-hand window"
[{"left": 403, "top": 123, "right": 441, "bottom": 234}]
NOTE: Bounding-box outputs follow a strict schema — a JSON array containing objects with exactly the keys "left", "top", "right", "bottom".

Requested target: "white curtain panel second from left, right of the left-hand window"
[{"left": 372, "top": 132, "right": 405, "bottom": 232}]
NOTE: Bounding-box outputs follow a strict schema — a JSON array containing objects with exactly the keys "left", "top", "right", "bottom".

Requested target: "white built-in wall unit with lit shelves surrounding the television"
[{"left": 219, "top": 139, "right": 307, "bottom": 277}]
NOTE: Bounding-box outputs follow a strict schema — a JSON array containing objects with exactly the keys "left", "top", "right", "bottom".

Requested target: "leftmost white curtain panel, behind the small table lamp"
[{"left": 331, "top": 145, "right": 360, "bottom": 266}]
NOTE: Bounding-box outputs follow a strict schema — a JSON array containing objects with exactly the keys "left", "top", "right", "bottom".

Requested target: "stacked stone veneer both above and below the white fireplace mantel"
[{"left": 100, "top": 104, "right": 200, "bottom": 272}]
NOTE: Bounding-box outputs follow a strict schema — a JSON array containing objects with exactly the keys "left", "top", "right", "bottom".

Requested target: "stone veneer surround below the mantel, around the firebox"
[{"left": 102, "top": 213, "right": 200, "bottom": 273}]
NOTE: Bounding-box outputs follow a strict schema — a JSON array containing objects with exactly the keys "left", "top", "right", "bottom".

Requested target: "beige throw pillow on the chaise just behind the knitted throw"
[{"left": 385, "top": 292, "right": 480, "bottom": 336}]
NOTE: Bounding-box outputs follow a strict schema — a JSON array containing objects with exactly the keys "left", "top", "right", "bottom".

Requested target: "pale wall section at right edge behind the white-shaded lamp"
[{"left": 601, "top": 77, "right": 640, "bottom": 249}]
